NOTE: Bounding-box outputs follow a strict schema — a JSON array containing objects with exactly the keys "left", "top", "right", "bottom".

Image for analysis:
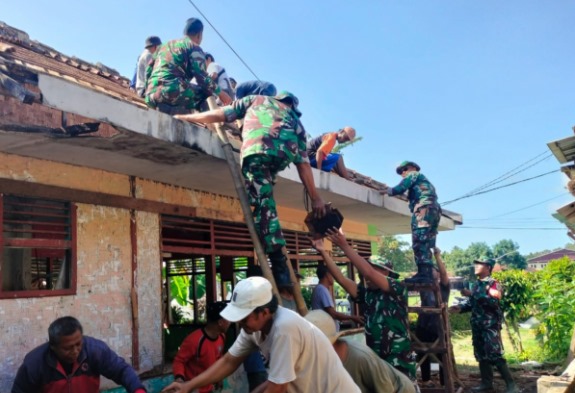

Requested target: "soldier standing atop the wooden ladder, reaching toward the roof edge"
[{"left": 381, "top": 161, "right": 441, "bottom": 283}]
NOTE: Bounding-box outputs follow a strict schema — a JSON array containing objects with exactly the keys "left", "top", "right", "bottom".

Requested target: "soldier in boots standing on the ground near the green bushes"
[{"left": 449, "top": 259, "right": 518, "bottom": 393}]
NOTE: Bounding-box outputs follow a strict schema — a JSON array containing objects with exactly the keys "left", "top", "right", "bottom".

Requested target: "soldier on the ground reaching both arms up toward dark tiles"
[{"left": 312, "top": 228, "right": 416, "bottom": 380}]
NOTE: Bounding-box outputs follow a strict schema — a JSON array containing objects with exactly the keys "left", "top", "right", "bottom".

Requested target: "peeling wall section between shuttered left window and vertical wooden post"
[{"left": 0, "top": 204, "right": 132, "bottom": 392}]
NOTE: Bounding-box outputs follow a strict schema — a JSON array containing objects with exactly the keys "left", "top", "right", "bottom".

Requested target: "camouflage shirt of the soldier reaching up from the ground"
[{"left": 357, "top": 277, "right": 416, "bottom": 380}]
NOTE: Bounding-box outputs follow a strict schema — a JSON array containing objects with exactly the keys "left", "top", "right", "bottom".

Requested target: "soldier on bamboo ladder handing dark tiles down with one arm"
[{"left": 175, "top": 92, "right": 325, "bottom": 286}]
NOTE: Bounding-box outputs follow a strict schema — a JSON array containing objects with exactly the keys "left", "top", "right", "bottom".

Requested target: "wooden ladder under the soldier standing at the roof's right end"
[{"left": 406, "top": 283, "right": 462, "bottom": 393}]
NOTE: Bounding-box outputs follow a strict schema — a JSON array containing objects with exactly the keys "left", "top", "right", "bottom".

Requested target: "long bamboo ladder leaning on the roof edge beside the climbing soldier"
[{"left": 207, "top": 96, "right": 307, "bottom": 316}]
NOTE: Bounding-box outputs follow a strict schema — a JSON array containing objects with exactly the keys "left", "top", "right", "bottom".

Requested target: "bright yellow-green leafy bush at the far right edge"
[{"left": 534, "top": 257, "right": 575, "bottom": 361}]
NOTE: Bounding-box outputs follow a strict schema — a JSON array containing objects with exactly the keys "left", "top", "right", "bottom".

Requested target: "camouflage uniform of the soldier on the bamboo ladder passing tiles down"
[{"left": 223, "top": 96, "right": 309, "bottom": 254}]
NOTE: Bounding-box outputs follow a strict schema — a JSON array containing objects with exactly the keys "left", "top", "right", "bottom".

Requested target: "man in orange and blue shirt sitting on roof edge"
[{"left": 307, "top": 127, "right": 355, "bottom": 179}]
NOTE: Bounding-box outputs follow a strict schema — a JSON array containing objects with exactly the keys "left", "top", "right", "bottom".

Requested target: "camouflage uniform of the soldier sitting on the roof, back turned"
[{"left": 145, "top": 37, "right": 220, "bottom": 110}]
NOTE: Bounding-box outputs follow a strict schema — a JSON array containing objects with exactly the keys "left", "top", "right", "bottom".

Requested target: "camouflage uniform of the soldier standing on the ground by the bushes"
[{"left": 461, "top": 276, "right": 503, "bottom": 364}]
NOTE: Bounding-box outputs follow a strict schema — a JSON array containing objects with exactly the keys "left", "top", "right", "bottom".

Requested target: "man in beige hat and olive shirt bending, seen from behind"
[{"left": 305, "top": 310, "right": 415, "bottom": 393}]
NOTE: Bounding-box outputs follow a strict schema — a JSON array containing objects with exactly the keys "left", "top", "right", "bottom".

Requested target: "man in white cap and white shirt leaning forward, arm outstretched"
[{"left": 162, "top": 277, "right": 361, "bottom": 393}]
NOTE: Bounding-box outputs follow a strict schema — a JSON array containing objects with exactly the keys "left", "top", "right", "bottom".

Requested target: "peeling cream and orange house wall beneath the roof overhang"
[{"left": 0, "top": 153, "right": 374, "bottom": 392}]
